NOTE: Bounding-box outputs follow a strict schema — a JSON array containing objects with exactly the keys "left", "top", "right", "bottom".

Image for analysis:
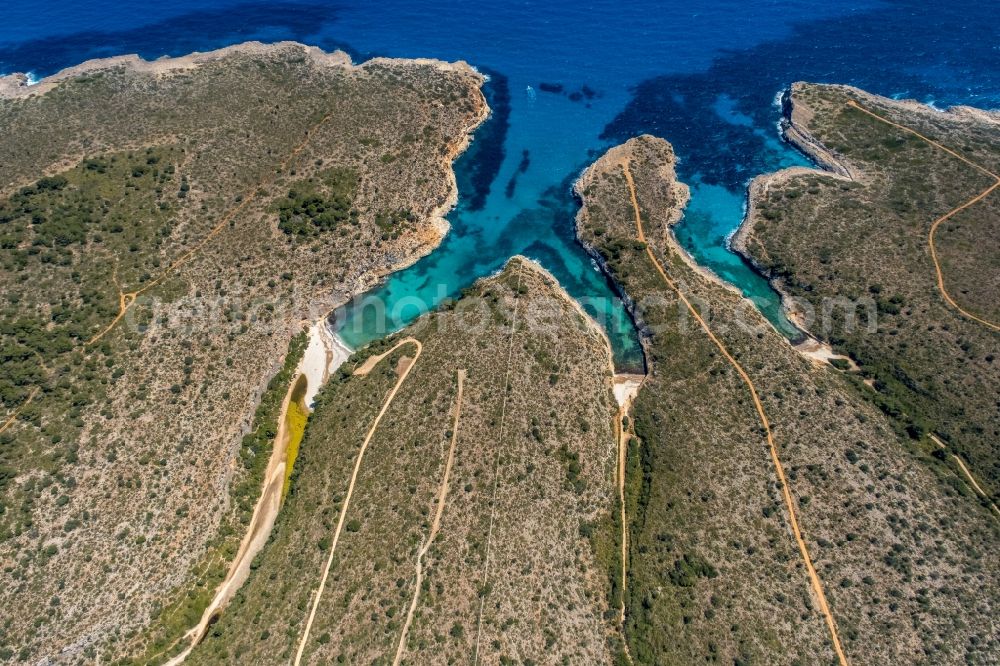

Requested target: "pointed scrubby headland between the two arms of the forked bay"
[{"left": 189, "top": 258, "right": 617, "bottom": 664}]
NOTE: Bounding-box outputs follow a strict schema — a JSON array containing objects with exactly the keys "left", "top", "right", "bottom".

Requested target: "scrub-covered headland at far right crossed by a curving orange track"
[{"left": 744, "top": 84, "right": 1000, "bottom": 508}]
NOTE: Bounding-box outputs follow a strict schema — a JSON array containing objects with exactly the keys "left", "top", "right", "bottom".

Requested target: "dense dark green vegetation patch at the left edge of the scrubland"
[{"left": 0, "top": 147, "right": 181, "bottom": 540}]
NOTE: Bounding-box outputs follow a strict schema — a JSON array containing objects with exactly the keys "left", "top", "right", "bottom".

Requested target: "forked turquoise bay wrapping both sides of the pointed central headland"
[{"left": 335, "top": 74, "right": 642, "bottom": 369}]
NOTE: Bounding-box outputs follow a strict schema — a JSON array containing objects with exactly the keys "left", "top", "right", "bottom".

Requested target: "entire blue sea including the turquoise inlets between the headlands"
[{"left": 0, "top": 0, "right": 1000, "bottom": 368}]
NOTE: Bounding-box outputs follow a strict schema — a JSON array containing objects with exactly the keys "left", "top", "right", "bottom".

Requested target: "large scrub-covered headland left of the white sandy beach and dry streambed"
[{"left": 0, "top": 44, "right": 487, "bottom": 663}]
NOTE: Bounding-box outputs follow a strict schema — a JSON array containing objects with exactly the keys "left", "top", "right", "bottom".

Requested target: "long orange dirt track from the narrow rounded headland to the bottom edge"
[{"left": 621, "top": 160, "right": 848, "bottom": 666}]
